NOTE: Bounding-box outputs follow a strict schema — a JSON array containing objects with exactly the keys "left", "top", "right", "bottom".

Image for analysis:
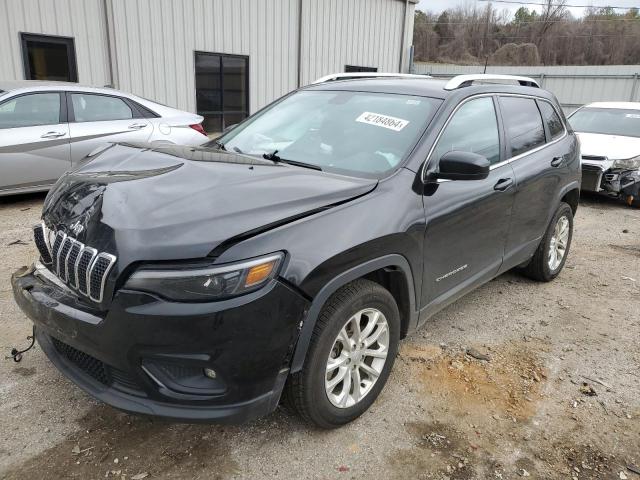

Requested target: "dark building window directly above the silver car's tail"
[{"left": 195, "top": 52, "right": 249, "bottom": 133}]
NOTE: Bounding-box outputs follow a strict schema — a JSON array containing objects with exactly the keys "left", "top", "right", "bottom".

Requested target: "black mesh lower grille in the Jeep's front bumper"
[{"left": 50, "top": 337, "right": 146, "bottom": 396}]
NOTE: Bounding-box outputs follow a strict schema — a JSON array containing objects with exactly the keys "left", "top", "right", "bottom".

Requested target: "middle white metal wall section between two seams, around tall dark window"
[{"left": 109, "top": 0, "right": 298, "bottom": 112}]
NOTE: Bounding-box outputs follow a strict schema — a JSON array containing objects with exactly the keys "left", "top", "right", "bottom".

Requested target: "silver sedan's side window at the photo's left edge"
[{"left": 0, "top": 93, "right": 60, "bottom": 128}]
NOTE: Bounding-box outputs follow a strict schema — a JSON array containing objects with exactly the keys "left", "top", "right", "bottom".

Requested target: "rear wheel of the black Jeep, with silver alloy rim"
[{"left": 524, "top": 202, "right": 573, "bottom": 282}]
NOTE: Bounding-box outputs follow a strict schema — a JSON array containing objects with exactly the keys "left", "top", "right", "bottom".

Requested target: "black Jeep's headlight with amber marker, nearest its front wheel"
[{"left": 124, "top": 252, "right": 284, "bottom": 302}]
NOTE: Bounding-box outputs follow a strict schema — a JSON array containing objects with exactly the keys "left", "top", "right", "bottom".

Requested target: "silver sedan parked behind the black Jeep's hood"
[{"left": 0, "top": 80, "right": 208, "bottom": 195}]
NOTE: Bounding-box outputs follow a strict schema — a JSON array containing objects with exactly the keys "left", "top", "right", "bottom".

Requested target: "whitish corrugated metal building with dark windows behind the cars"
[{"left": 0, "top": 0, "right": 418, "bottom": 131}]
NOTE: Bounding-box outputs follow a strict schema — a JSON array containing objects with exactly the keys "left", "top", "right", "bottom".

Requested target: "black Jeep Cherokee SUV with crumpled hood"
[{"left": 12, "top": 76, "right": 580, "bottom": 428}]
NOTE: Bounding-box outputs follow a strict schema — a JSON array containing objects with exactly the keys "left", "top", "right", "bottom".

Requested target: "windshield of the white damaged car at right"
[{"left": 569, "top": 108, "right": 640, "bottom": 137}]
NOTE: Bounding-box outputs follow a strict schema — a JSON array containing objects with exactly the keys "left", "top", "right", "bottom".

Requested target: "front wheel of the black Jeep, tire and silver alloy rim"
[{"left": 287, "top": 280, "right": 400, "bottom": 428}]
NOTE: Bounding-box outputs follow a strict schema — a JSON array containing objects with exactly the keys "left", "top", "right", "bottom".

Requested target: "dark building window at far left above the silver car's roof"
[{"left": 20, "top": 33, "right": 78, "bottom": 82}]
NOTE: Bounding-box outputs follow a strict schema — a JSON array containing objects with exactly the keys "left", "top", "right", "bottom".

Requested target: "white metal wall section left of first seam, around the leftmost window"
[{"left": 0, "top": 0, "right": 109, "bottom": 86}]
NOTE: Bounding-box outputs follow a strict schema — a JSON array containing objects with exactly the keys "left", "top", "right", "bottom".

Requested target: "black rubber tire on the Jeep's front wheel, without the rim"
[{"left": 285, "top": 280, "right": 400, "bottom": 429}]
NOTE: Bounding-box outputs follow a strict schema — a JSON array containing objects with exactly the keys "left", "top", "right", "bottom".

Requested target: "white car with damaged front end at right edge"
[{"left": 569, "top": 102, "right": 640, "bottom": 207}]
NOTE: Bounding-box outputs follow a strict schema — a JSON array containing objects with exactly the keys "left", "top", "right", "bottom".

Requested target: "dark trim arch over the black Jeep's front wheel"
[{"left": 290, "top": 254, "right": 418, "bottom": 373}]
